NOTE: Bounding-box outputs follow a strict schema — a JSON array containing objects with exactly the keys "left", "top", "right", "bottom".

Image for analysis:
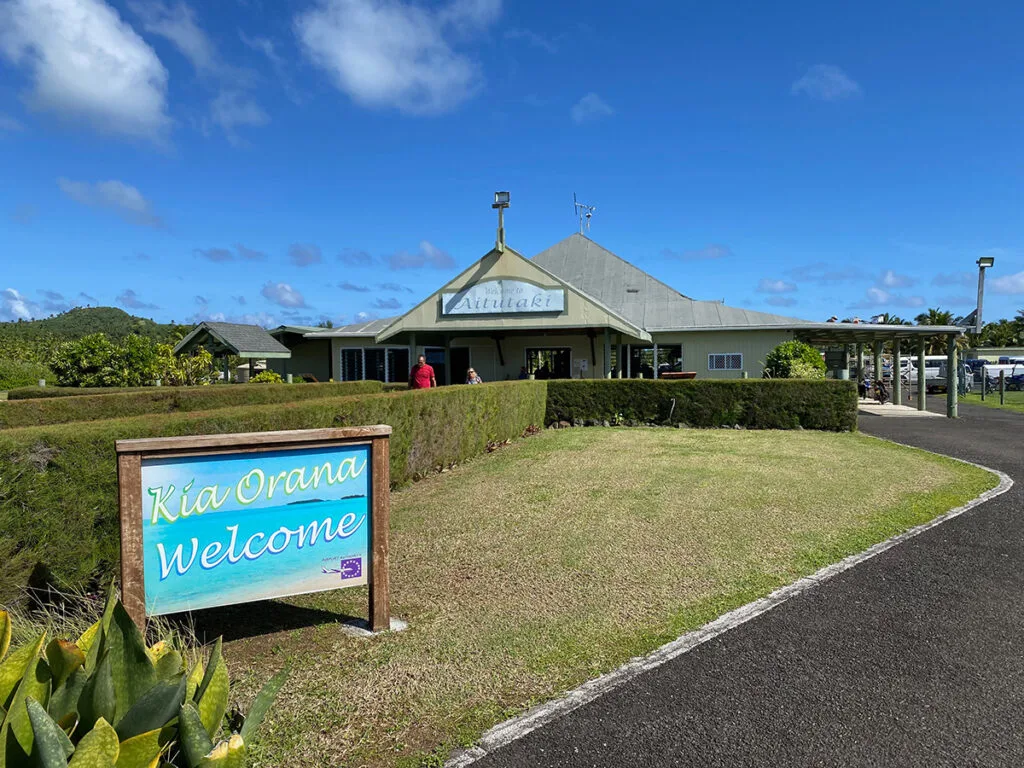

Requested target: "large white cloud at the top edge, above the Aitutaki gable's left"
[{"left": 295, "top": 0, "right": 501, "bottom": 115}]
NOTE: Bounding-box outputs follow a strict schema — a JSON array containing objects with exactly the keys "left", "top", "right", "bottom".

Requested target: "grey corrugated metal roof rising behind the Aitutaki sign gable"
[{"left": 532, "top": 233, "right": 808, "bottom": 332}]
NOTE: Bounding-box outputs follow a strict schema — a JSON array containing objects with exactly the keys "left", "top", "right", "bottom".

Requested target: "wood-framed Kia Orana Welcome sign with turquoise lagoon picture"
[{"left": 117, "top": 425, "right": 391, "bottom": 632}]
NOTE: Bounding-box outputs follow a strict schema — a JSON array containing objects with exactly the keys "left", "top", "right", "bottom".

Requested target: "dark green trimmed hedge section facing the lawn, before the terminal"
[{"left": 546, "top": 379, "right": 857, "bottom": 431}]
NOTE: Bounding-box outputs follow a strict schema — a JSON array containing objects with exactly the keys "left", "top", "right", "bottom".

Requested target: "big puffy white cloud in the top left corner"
[{"left": 0, "top": 0, "right": 170, "bottom": 142}]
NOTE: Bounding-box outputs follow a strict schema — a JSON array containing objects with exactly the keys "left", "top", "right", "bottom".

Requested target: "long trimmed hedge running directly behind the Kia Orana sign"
[{"left": 0, "top": 382, "right": 546, "bottom": 603}]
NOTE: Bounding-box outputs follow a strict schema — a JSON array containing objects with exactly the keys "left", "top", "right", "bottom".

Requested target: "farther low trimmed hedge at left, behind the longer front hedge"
[{"left": 0, "top": 381, "right": 383, "bottom": 429}]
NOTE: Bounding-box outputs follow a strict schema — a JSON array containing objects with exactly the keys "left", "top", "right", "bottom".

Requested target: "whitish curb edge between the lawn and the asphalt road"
[{"left": 444, "top": 448, "right": 1014, "bottom": 768}]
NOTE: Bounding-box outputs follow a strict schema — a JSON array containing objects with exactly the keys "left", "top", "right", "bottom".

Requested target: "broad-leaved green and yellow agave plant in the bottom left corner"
[{"left": 0, "top": 590, "right": 288, "bottom": 768}]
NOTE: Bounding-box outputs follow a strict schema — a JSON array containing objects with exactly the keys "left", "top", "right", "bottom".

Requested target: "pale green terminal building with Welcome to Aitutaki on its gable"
[{"left": 269, "top": 211, "right": 847, "bottom": 384}]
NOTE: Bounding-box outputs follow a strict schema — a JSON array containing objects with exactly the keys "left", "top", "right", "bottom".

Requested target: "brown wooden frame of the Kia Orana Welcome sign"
[{"left": 116, "top": 424, "right": 391, "bottom": 632}]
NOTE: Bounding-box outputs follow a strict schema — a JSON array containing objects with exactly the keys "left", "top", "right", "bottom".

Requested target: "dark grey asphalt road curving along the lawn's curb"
[{"left": 474, "top": 398, "right": 1024, "bottom": 768}]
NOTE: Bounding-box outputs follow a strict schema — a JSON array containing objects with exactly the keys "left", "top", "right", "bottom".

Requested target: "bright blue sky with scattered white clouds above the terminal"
[{"left": 0, "top": 0, "right": 1024, "bottom": 325}]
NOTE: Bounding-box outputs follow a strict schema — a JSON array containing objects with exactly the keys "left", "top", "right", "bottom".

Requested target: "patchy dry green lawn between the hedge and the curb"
[{"left": 220, "top": 428, "right": 996, "bottom": 766}]
